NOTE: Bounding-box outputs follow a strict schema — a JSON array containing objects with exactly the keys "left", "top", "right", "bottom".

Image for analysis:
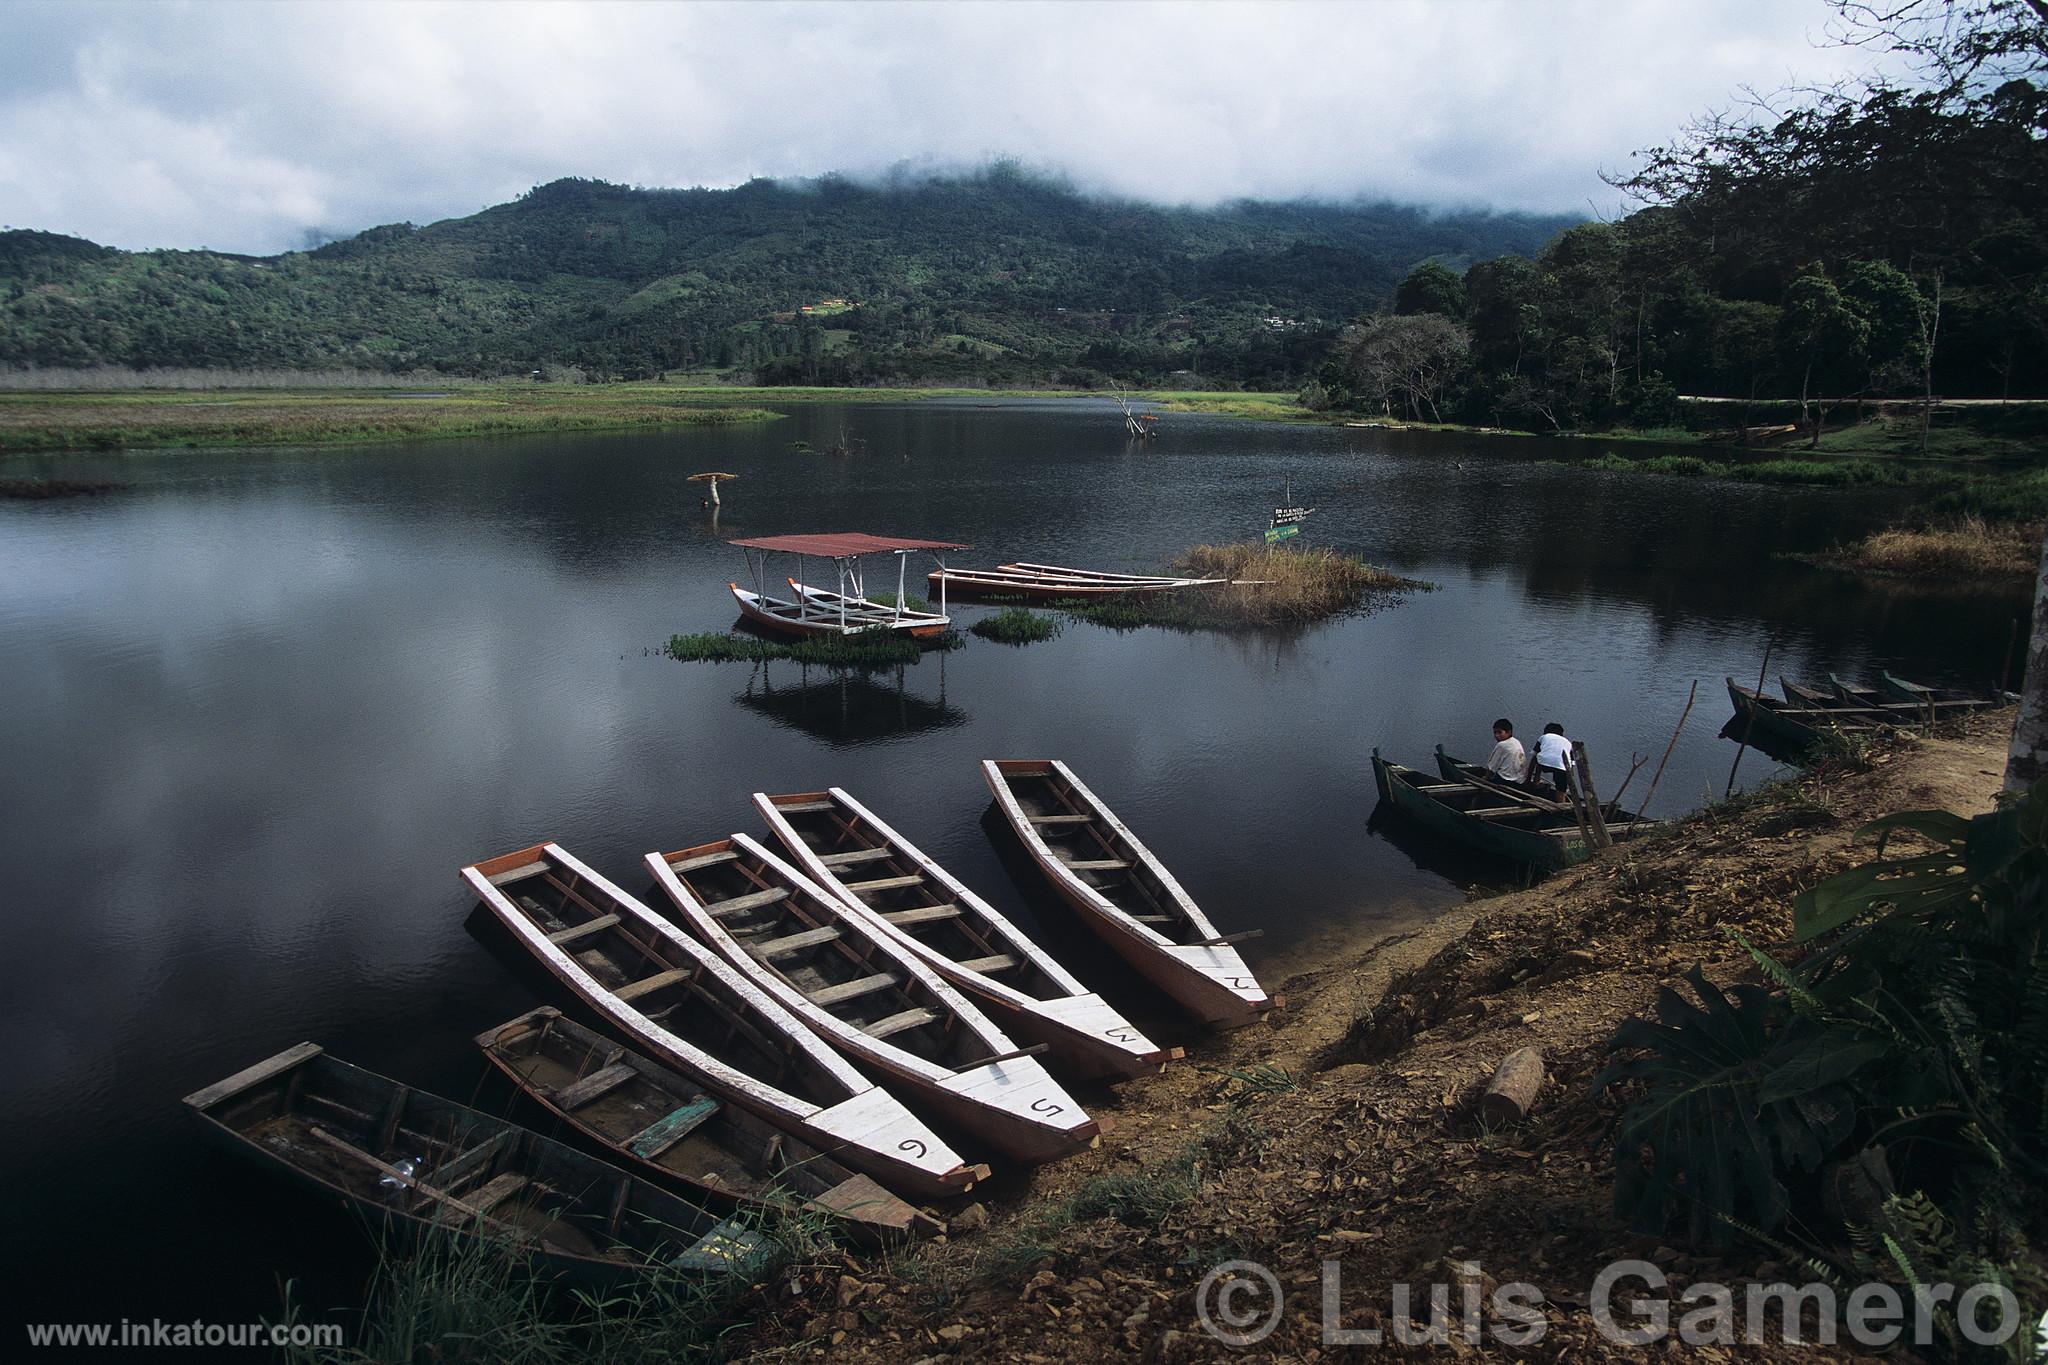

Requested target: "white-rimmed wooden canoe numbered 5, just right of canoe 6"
[{"left": 647, "top": 835, "right": 1100, "bottom": 1162}]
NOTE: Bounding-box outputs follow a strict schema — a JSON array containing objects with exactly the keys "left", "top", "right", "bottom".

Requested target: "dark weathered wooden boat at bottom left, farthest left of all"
[{"left": 184, "top": 1044, "right": 768, "bottom": 1283}]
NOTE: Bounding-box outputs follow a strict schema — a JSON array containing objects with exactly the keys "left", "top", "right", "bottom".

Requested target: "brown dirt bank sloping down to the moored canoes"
[{"left": 735, "top": 712, "right": 2011, "bottom": 1361}]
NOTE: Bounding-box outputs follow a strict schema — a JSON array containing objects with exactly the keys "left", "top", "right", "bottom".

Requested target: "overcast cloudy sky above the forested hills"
[{"left": 0, "top": 0, "right": 1900, "bottom": 252}]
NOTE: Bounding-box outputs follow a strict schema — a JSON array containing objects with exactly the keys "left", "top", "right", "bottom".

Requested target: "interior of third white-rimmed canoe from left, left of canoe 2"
[{"left": 770, "top": 792, "right": 1073, "bottom": 1001}]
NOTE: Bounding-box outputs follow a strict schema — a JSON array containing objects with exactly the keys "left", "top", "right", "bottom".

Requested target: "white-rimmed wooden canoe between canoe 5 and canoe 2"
[{"left": 754, "top": 788, "right": 1180, "bottom": 1081}]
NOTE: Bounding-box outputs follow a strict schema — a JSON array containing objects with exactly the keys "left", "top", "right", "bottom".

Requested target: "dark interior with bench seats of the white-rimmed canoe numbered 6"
[{"left": 479, "top": 853, "right": 846, "bottom": 1107}]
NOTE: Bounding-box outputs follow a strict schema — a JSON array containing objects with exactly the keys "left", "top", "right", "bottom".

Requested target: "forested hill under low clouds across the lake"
[{"left": 0, "top": 166, "right": 1571, "bottom": 383}]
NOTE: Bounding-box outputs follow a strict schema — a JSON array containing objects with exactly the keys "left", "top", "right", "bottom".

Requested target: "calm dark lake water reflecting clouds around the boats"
[{"left": 0, "top": 399, "right": 2025, "bottom": 1320}]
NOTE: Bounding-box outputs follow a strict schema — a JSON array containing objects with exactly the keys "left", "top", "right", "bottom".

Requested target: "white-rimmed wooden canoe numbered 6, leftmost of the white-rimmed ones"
[{"left": 463, "top": 843, "right": 989, "bottom": 1199}]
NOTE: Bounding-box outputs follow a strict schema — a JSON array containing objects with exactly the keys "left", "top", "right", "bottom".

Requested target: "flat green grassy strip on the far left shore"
[{"left": 0, "top": 385, "right": 776, "bottom": 454}]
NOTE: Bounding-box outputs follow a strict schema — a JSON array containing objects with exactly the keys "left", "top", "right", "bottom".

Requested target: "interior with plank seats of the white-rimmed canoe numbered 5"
[{"left": 666, "top": 839, "right": 997, "bottom": 1070}]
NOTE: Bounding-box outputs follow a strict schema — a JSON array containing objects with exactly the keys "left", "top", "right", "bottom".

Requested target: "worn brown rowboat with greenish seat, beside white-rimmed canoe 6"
[{"left": 477, "top": 1005, "right": 946, "bottom": 1244}]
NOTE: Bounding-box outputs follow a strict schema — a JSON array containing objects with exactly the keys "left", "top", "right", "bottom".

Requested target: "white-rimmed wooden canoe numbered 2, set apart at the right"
[{"left": 981, "top": 759, "right": 1282, "bottom": 1029}]
